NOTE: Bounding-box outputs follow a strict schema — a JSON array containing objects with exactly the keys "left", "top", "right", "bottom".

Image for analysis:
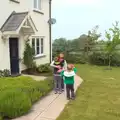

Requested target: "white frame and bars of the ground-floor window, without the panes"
[{"left": 31, "top": 36, "right": 45, "bottom": 57}]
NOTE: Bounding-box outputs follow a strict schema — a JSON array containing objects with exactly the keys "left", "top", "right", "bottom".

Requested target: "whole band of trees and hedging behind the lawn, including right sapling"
[{"left": 53, "top": 22, "right": 120, "bottom": 66}]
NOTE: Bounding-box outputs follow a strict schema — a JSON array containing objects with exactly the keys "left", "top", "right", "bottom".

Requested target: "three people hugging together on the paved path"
[{"left": 50, "top": 53, "right": 77, "bottom": 100}]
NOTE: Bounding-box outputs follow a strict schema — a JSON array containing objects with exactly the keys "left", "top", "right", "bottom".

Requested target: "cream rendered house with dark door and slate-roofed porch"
[{"left": 0, "top": 0, "right": 51, "bottom": 74}]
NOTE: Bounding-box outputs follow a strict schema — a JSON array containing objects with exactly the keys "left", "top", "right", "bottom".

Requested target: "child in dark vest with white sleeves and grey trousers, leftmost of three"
[{"left": 50, "top": 57, "right": 62, "bottom": 94}]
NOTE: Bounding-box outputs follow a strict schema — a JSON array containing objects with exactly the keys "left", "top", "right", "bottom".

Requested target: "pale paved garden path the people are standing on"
[{"left": 14, "top": 76, "right": 82, "bottom": 120}]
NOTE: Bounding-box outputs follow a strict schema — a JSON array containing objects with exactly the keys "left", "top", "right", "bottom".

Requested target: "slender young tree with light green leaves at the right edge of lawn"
[{"left": 105, "top": 22, "right": 120, "bottom": 68}]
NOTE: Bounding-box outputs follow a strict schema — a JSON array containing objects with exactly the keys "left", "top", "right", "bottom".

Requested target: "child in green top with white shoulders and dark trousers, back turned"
[{"left": 61, "top": 64, "right": 76, "bottom": 100}]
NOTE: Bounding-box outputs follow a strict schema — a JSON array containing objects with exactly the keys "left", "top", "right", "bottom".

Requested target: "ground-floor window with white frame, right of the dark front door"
[{"left": 32, "top": 37, "right": 44, "bottom": 56}]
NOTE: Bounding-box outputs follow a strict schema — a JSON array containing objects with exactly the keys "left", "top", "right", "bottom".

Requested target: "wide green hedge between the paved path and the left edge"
[{"left": 0, "top": 76, "right": 53, "bottom": 119}]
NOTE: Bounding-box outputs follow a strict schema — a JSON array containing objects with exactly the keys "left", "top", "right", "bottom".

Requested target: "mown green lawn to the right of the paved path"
[{"left": 57, "top": 65, "right": 120, "bottom": 120}]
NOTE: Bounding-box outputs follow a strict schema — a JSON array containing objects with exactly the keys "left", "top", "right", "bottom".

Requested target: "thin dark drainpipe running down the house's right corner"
[{"left": 49, "top": 0, "right": 52, "bottom": 63}]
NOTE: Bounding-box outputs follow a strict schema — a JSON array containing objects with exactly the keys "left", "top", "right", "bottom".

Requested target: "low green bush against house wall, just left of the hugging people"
[{"left": 37, "top": 63, "right": 51, "bottom": 73}]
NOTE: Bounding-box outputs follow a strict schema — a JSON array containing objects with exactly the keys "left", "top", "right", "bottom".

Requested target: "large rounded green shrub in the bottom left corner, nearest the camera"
[{"left": 0, "top": 89, "right": 31, "bottom": 118}]
